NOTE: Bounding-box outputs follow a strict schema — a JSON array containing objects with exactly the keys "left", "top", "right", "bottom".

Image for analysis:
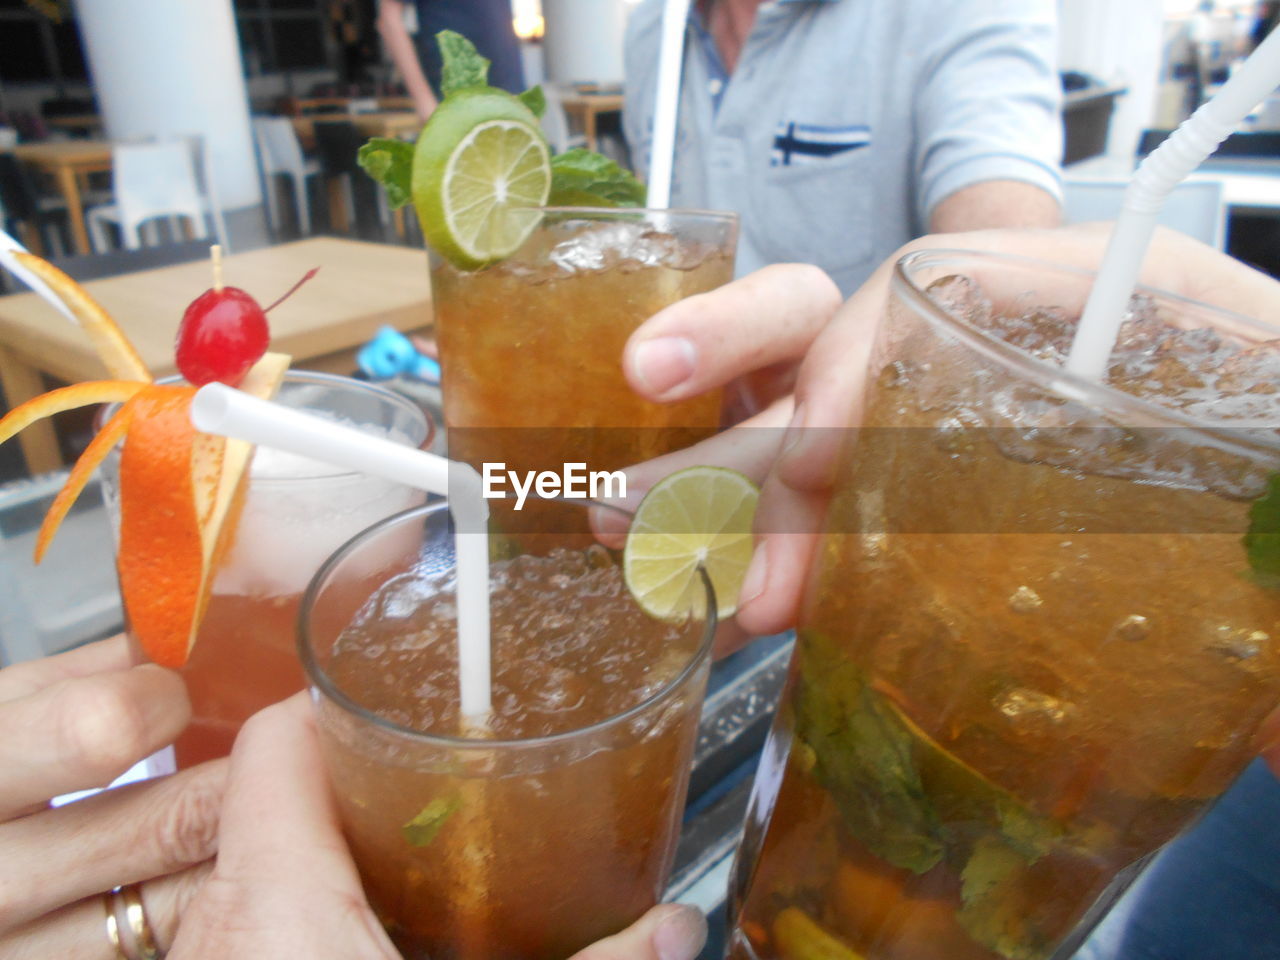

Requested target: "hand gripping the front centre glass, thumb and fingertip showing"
[{"left": 169, "top": 694, "right": 707, "bottom": 960}]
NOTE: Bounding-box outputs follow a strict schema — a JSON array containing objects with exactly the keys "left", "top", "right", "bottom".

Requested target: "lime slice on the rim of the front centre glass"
[{"left": 622, "top": 467, "right": 760, "bottom": 621}]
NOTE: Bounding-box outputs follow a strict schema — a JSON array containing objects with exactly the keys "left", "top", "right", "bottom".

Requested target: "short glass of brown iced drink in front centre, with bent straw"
[{"left": 300, "top": 503, "right": 714, "bottom": 960}]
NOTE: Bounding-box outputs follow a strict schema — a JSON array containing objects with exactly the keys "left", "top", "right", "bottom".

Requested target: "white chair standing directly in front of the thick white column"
[{"left": 86, "top": 137, "right": 227, "bottom": 252}]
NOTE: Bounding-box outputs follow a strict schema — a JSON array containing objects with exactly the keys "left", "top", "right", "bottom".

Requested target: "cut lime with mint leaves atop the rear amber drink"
[{"left": 413, "top": 87, "right": 552, "bottom": 270}]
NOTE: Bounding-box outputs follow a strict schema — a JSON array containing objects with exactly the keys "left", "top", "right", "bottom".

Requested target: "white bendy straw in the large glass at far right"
[{"left": 1066, "top": 31, "right": 1280, "bottom": 379}]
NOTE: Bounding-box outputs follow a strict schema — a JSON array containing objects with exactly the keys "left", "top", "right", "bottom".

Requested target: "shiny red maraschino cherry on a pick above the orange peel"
[{"left": 175, "top": 246, "right": 274, "bottom": 387}]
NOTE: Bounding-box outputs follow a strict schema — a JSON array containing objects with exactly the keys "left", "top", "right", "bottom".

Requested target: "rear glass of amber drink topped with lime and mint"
[{"left": 431, "top": 207, "right": 737, "bottom": 529}]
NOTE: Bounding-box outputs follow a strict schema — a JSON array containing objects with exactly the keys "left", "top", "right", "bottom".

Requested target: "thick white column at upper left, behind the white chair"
[{"left": 76, "top": 0, "right": 262, "bottom": 210}]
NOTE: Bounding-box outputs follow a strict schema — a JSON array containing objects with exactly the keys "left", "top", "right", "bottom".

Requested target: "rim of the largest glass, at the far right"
[{"left": 891, "top": 247, "right": 1280, "bottom": 448}]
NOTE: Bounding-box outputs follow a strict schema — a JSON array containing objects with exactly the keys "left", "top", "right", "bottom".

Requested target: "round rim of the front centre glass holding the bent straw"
[{"left": 294, "top": 499, "right": 719, "bottom": 751}]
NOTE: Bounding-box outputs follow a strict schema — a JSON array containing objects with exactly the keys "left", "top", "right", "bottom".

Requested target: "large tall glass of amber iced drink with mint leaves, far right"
[{"left": 731, "top": 251, "right": 1280, "bottom": 960}]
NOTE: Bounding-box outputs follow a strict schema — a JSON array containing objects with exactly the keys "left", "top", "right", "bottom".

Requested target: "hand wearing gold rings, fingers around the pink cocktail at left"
[{"left": 0, "top": 636, "right": 225, "bottom": 960}]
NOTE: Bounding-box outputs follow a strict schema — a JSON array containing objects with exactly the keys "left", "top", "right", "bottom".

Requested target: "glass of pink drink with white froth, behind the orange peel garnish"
[{"left": 102, "top": 370, "right": 433, "bottom": 768}]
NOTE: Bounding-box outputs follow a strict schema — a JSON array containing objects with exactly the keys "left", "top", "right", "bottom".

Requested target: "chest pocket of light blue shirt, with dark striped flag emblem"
[{"left": 742, "top": 134, "right": 874, "bottom": 271}]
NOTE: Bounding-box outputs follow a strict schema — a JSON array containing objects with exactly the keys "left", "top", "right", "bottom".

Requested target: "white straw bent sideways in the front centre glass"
[{"left": 191, "top": 383, "right": 490, "bottom": 728}]
